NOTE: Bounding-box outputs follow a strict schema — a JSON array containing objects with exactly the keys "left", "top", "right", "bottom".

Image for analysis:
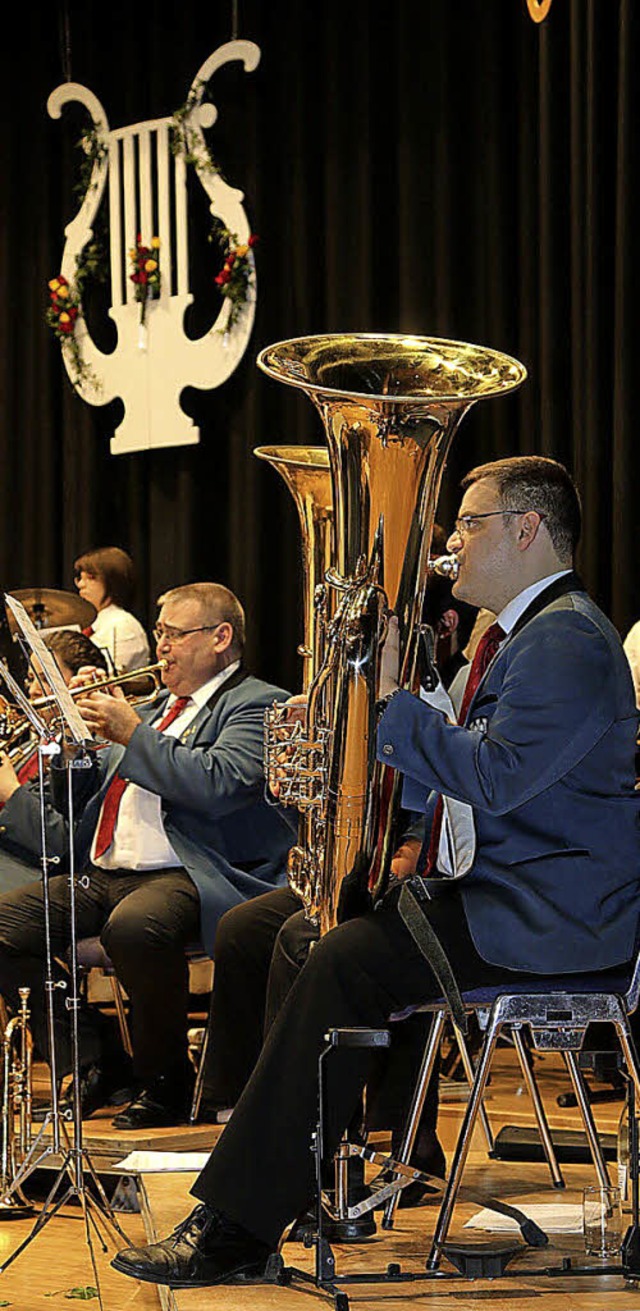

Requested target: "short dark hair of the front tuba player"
[{"left": 460, "top": 455, "right": 582, "bottom": 560}]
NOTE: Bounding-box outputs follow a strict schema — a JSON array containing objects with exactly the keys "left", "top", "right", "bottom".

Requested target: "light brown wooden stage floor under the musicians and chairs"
[{"left": 0, "top": 1047, "right": 640, "bottom": 1311}]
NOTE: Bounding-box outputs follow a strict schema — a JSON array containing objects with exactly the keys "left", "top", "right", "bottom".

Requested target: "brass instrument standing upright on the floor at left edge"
[{"left": 0, "top": 987, "right": 33, "bottom": 1219}]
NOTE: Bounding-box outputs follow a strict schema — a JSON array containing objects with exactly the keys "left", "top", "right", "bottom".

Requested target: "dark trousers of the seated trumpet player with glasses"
[{"left": 0, "top": 868, "right": 199, "bottom": 1083}]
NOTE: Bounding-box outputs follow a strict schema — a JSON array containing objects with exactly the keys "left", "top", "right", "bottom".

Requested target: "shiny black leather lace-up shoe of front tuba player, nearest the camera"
[{"left": 111, "top": 1205, "right": 271, "bottom": 1289}]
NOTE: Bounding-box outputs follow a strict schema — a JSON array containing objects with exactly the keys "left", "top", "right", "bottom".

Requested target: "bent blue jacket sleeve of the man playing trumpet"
[{"left": 119, "top": 696, "right": 278, "bottom": 819}]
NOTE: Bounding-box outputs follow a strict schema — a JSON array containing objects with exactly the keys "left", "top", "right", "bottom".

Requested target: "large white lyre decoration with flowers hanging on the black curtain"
[{"left": 47, "top": 41, "right": 260, "bottom": 455}]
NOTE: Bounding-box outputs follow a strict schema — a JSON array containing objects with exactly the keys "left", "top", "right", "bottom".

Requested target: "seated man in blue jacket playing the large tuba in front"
[{"left": 113, "top": 456, "right": 640, "bottom": 1287}]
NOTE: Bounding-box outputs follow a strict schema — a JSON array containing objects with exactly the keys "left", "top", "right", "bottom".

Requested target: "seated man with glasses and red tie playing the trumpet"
[{"left": 0, "top": 583, "right": 294, "bottom": 1129}]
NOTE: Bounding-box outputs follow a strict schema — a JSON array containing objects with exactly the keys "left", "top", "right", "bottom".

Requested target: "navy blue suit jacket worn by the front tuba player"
[{"left": 378, "top": 574, "right": 640, "bottom": 974}]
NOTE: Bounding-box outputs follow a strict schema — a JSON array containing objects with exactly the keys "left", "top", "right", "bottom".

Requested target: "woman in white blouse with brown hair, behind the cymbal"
[{"left": 73, "top": 547, "right": 150, "bottom": 673}]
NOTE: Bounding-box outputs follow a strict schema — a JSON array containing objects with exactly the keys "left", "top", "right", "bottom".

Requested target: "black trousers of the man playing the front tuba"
[{"left": 193, "top": 889, "right": 540, "bottom": 1247}]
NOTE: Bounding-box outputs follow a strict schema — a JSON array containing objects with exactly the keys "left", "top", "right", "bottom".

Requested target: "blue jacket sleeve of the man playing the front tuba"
[{"left": 378, "top": 611, "right": 620, "bottom": 814}]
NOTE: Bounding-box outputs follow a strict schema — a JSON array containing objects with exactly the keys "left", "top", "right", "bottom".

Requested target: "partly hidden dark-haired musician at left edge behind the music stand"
[{"left": 0, "top": 628, "right": 106, "bottom": 891}]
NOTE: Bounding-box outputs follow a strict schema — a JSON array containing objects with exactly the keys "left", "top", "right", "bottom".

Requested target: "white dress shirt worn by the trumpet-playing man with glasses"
[{"left": 90, "top": 659, "right": 240, "bottom": 871}]
